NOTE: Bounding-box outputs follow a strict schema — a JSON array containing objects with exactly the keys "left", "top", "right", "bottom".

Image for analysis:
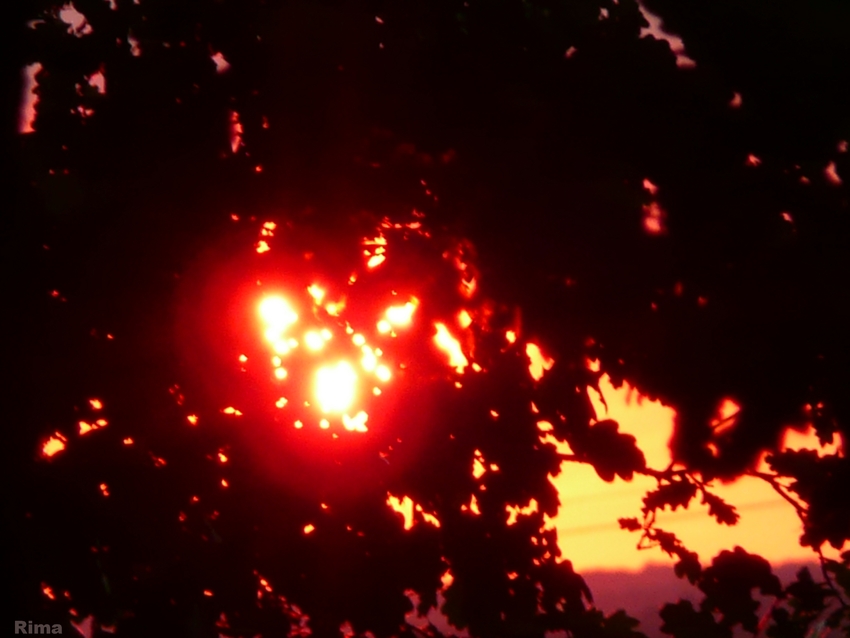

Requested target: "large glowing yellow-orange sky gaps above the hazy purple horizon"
[{"left": 552, "top": 375, "right": 839, "bottom": 571}]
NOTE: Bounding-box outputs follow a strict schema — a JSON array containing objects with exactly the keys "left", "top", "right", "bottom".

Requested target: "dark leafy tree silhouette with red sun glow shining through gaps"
[{"left": 3, "top": 0, "right": 850, "bottom": 638}]
